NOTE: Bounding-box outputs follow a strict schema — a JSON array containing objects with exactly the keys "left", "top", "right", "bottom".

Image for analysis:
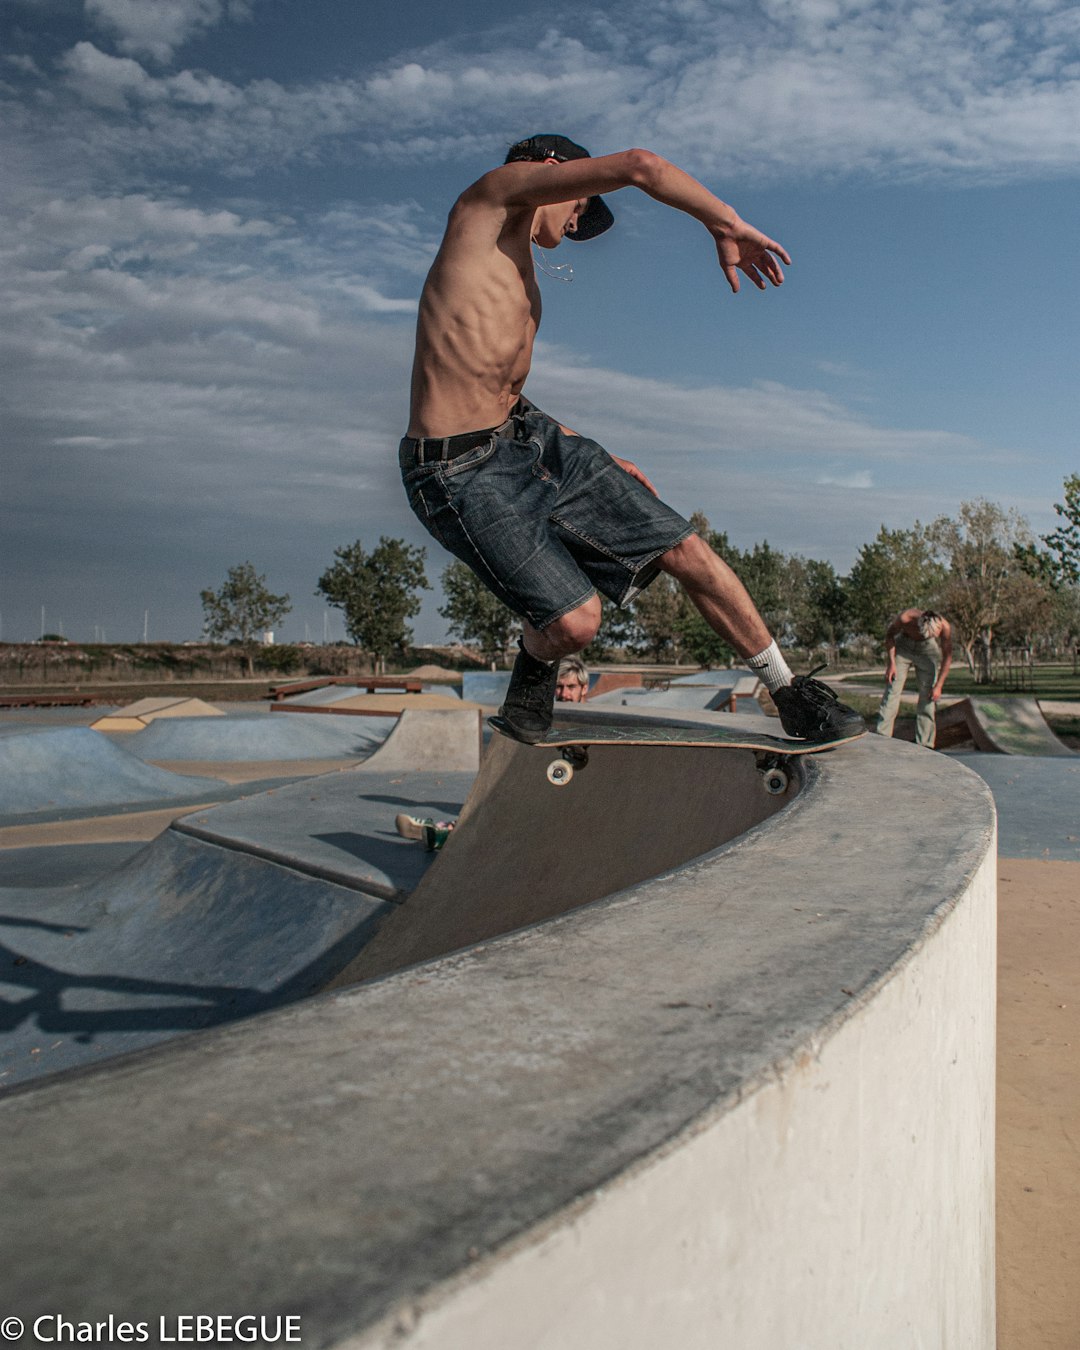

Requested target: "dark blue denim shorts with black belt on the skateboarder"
[{"left": 398, "top": 398, "right": 694, "bottom": 629}]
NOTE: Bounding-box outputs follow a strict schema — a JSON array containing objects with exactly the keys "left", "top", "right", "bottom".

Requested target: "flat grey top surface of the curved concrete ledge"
[{"left": 0, "top": 737, "right": 995, "bottom": 1347}]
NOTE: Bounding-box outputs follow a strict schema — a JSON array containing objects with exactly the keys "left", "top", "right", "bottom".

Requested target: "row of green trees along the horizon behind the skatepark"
[{"left": 201, "top": 474, "right": 1080, "bottom": 682}]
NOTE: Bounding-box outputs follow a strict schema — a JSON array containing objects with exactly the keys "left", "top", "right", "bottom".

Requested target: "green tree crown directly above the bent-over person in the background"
[{"left": 844, "top": 521, "right": 945, "bottom": 641}]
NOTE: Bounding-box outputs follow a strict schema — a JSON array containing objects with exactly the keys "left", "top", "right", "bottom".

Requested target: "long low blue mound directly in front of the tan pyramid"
[{"left": 120, "top": 711, "right": 394, "bottom": 763}]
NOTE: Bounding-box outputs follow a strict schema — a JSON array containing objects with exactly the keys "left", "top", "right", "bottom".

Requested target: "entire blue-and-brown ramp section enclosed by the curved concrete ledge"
[{"left": 0, "top": 709, "right": 783, "bottom": 1087}]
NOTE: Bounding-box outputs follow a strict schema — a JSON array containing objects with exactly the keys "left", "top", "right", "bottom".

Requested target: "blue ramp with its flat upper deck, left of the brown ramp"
[{"left": 0, "top": 761, "right": 474, "bottom": 1088}]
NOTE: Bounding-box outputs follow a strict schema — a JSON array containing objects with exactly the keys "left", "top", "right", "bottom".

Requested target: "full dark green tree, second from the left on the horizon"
[{"left": 316, "top": 535, "right": 431, "bottom": 672}]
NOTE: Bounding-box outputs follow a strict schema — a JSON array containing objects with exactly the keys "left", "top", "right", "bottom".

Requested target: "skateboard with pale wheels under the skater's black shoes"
[{"left": 487, "top": 717, "right": 867, "bottom": 795}]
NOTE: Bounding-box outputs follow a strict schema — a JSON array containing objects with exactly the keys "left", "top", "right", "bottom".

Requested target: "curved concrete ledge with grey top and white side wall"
[{"left": 0, "top": 737, "right": 995, "bottom": 1350}]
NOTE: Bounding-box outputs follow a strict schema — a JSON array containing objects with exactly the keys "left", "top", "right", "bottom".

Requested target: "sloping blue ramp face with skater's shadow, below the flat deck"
[{"left": 0, "top": 829, "right": 387, "bottom": 1087}]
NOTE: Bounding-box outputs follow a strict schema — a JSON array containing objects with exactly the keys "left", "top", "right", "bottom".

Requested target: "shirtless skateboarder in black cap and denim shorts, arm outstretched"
[{"left": 400, "top": 135, "right": 864, "bottom": 744}]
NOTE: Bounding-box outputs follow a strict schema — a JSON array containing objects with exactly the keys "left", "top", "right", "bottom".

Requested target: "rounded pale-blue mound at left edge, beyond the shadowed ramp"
[{"left": 0, "top": 734, "right": 223, "bottom": 817}]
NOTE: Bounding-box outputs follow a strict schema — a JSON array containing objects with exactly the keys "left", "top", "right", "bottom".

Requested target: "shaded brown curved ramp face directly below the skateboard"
[{"left": 333, "top": 707, "right": 803, "bottom": 987}]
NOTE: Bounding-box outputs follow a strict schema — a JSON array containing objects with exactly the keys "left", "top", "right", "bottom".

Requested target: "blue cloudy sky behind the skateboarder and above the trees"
[{"left": 0, "top": 0, "right": 1080, "bottom": 643}]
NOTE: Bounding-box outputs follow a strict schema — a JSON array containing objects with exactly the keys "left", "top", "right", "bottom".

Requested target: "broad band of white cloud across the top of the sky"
[{"left": 33, "top": 0, "right": 1080, "bottom": 181}]
